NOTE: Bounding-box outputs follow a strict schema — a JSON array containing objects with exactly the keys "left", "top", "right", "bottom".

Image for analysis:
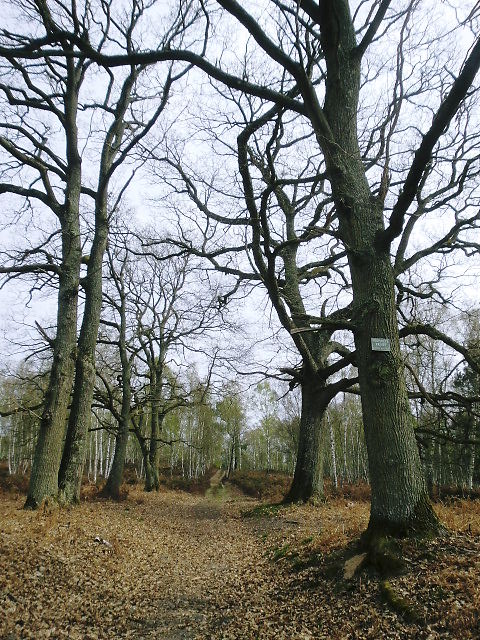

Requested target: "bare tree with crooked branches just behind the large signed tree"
[{"left": 150, "top": 99, "right": 357, "bottom": 501}]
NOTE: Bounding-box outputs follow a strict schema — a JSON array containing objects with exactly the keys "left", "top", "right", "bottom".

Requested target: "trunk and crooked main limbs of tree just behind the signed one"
[{"left": 237, "top": 108, "right": 351, "bottom": 502}]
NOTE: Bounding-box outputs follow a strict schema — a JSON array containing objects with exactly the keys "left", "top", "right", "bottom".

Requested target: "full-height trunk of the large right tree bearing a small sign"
[{"left": 301, "top": 1, "right": 439, "bottom": 534}]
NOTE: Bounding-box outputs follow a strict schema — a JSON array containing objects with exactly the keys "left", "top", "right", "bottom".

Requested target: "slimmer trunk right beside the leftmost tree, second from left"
[{"left": 58, "top": 218, "right": 108, "bottom": 503}]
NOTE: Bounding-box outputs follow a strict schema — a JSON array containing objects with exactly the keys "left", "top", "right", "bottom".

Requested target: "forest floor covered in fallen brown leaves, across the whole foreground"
[{"left": 0, "top": 477, "right": 480, "bottom": 640}]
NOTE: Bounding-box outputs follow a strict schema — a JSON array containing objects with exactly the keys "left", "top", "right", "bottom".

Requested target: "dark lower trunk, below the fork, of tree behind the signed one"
[{"left": 284, "top": 378, "right": 330, "bottom": 502}]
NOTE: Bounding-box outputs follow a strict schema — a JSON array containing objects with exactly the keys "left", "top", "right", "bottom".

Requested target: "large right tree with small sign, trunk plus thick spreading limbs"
[{"left": 212, "top": 0, "right": 480, "bottom": 532}]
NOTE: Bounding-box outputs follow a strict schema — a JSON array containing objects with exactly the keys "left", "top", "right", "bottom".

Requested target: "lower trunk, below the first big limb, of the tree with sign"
[{"left": 351, "top": 245, "right": 438, "bottom": 534}]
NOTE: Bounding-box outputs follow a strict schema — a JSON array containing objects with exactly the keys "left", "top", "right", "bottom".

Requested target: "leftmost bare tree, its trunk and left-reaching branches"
[{"left": 0, "top": 2, "right": 91, "bottom": 507}]
